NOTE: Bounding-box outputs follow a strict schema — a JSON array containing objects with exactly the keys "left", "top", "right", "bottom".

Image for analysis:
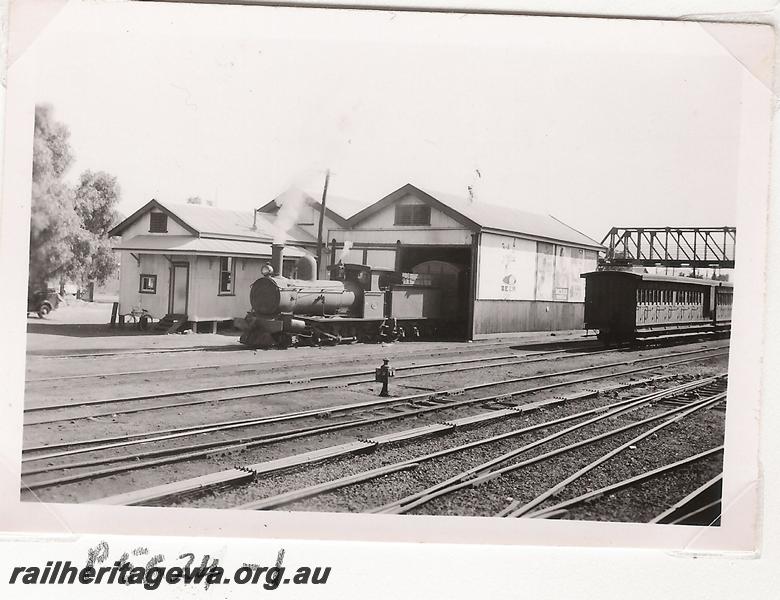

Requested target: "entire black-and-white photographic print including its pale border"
[{"left": 3, "top": 1, "right": 774, "bottom": 550}]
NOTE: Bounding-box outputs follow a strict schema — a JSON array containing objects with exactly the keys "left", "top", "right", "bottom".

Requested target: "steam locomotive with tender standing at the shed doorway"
[{"left": 239, "top": 247, "right": 465, "bottom": 348}]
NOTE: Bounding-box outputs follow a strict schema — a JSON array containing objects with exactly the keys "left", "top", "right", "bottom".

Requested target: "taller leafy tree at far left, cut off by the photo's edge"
[{"left": 30, "top": 106, "right": 79, "bottom": 287}]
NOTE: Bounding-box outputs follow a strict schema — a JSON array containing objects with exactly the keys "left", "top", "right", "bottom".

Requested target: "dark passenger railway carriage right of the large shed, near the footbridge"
[{"left": 582, "top": 271, "right": 734, "bottom": 343}]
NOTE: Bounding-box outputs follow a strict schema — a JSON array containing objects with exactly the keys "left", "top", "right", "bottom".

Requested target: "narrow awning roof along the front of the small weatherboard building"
[{"left": 113, "top": 235, "right": 307, "bottom": 258}]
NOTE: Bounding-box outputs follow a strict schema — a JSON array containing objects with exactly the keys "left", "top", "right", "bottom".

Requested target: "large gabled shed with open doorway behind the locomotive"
[{"left": 327, "top": 184, "right": 604, "bottom": 338}]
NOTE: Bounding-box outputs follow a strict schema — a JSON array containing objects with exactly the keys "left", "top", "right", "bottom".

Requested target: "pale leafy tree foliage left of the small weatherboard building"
[{"left": 30, "top": 106, "right": 119, "bottom": 288}]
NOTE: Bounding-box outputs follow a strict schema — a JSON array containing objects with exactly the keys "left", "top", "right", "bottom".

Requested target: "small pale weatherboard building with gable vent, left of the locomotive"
[{"left": 109, "top": 200, "right": 317, "bottom": 332}]
